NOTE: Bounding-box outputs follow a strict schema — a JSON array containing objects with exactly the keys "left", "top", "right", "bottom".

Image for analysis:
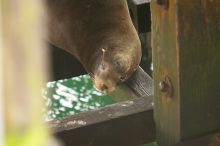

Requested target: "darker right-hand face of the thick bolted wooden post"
[{"left": 177, "top": 0, "right": 220, "bottom": 139}]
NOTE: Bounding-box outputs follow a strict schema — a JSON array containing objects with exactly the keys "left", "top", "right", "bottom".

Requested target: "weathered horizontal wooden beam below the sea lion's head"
[{"left": 49, "top": 96, "right": 155, "bottom": 146}]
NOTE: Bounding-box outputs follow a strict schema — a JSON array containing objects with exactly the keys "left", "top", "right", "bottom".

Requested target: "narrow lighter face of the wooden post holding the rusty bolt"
[{"left": 151, "top": 0, "right": 181, "bottom": 146}]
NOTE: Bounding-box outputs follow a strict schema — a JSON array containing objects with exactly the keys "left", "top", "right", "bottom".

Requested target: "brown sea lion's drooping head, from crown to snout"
[{"left": 90, "top": 38, "right": 141, "bottom": 93}]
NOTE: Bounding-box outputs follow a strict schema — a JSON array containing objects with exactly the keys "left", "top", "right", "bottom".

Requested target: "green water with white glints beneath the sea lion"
[{"left": 43, "top": 75, "right": 114, "bottom": 121}]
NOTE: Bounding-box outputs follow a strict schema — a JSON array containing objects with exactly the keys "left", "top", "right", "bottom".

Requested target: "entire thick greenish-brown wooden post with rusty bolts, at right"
[{"left": 151, "top": 0, "right": 220, "bottom": 146}]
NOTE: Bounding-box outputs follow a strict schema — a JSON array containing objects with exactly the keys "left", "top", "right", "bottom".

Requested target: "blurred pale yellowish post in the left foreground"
[{"left": 1, "top": 0, "right": 52, "bottom": 146}]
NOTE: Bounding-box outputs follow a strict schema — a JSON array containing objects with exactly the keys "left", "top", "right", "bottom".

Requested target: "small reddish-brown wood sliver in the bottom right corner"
[{"left": 175, "top": 133, "right": 220, "bottom": 146}]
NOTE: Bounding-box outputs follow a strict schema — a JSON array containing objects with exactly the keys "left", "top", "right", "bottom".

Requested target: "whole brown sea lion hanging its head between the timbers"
[{"left": 46, "top": 0, "right": 141, "bottom": 93}]
